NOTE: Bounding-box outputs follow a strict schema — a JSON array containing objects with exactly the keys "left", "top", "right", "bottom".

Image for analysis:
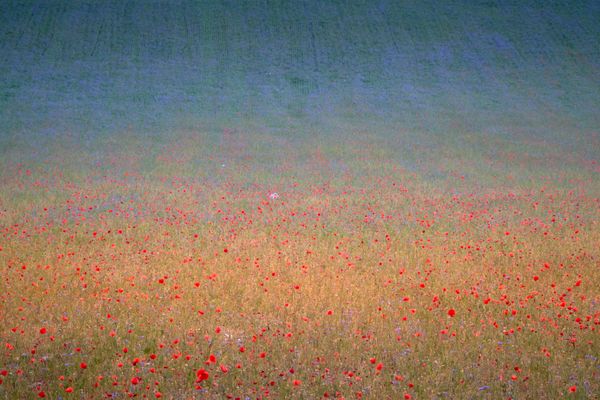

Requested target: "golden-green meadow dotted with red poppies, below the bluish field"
[{"left": 0, "top": 129, "right": 600, "bottom": 399}]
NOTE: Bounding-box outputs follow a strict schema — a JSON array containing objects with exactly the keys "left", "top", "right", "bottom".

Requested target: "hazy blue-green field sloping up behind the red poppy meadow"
[{"left": 0, "top": 0, "right": 600, "bottom": 173}]
